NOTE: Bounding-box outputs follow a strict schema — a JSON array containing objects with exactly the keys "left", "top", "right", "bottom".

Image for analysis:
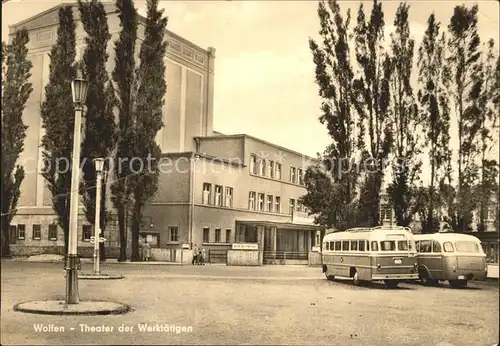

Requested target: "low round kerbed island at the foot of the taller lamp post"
[{"left": 13, "top": 300, "right": 131, "bottom": 316}]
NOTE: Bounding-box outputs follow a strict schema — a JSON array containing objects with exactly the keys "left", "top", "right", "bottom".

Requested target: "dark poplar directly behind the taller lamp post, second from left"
[{"left": 40, "top": 6, "right": 76, "bottom": 253}]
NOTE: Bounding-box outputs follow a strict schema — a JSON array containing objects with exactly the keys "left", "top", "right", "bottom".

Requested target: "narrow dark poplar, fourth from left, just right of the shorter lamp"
[{"left": 111, "top": 0, "right": 137, "bottom": 261}]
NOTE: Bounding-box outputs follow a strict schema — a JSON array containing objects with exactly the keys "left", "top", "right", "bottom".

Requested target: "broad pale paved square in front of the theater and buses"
[{"left": 1, "top": 261, "right": 499, "bottom": 346}]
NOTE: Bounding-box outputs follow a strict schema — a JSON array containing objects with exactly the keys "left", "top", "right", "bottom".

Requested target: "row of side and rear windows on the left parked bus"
[{"left": 325, "top": 240, "right": 411, "bottom": 251}]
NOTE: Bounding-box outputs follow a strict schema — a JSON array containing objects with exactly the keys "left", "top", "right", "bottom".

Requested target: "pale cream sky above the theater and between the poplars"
[{"left": 2, "top": 0, "right": 500, "bottom": 184}]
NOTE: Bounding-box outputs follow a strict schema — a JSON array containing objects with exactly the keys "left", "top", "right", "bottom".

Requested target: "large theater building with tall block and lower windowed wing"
[{"left": 9, "top": 4, "right": 322, "bottom": 263}]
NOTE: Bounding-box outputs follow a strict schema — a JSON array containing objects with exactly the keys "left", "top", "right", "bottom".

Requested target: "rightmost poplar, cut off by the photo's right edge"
[{"left": 475, "top": 40, "right": 500, "bottom": 231}]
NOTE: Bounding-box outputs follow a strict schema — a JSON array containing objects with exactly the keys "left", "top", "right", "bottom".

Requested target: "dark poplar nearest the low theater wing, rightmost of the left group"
[{"left": 131, "top": 0, "right": 167, "bottom": 261}]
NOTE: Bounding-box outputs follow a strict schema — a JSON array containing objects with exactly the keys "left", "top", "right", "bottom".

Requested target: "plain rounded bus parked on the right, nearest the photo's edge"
[{"left": 415, "top": 233, "right": 488, "bottom": 288}]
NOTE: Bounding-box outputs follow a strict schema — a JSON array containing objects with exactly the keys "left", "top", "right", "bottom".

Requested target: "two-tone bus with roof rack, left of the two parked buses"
[{"left": 322, "top": 226, "right": 418, "bottom": 288}]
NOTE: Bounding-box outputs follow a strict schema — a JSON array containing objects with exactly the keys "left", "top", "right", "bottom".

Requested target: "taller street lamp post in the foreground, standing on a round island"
[{"left": 66, "top": 78, "right": 88, "bottom": 304}]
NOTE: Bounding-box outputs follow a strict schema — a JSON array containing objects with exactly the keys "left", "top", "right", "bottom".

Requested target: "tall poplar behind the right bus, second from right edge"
[{"left": 447, "top": 5, "right": 482, "bottom": 232}]
